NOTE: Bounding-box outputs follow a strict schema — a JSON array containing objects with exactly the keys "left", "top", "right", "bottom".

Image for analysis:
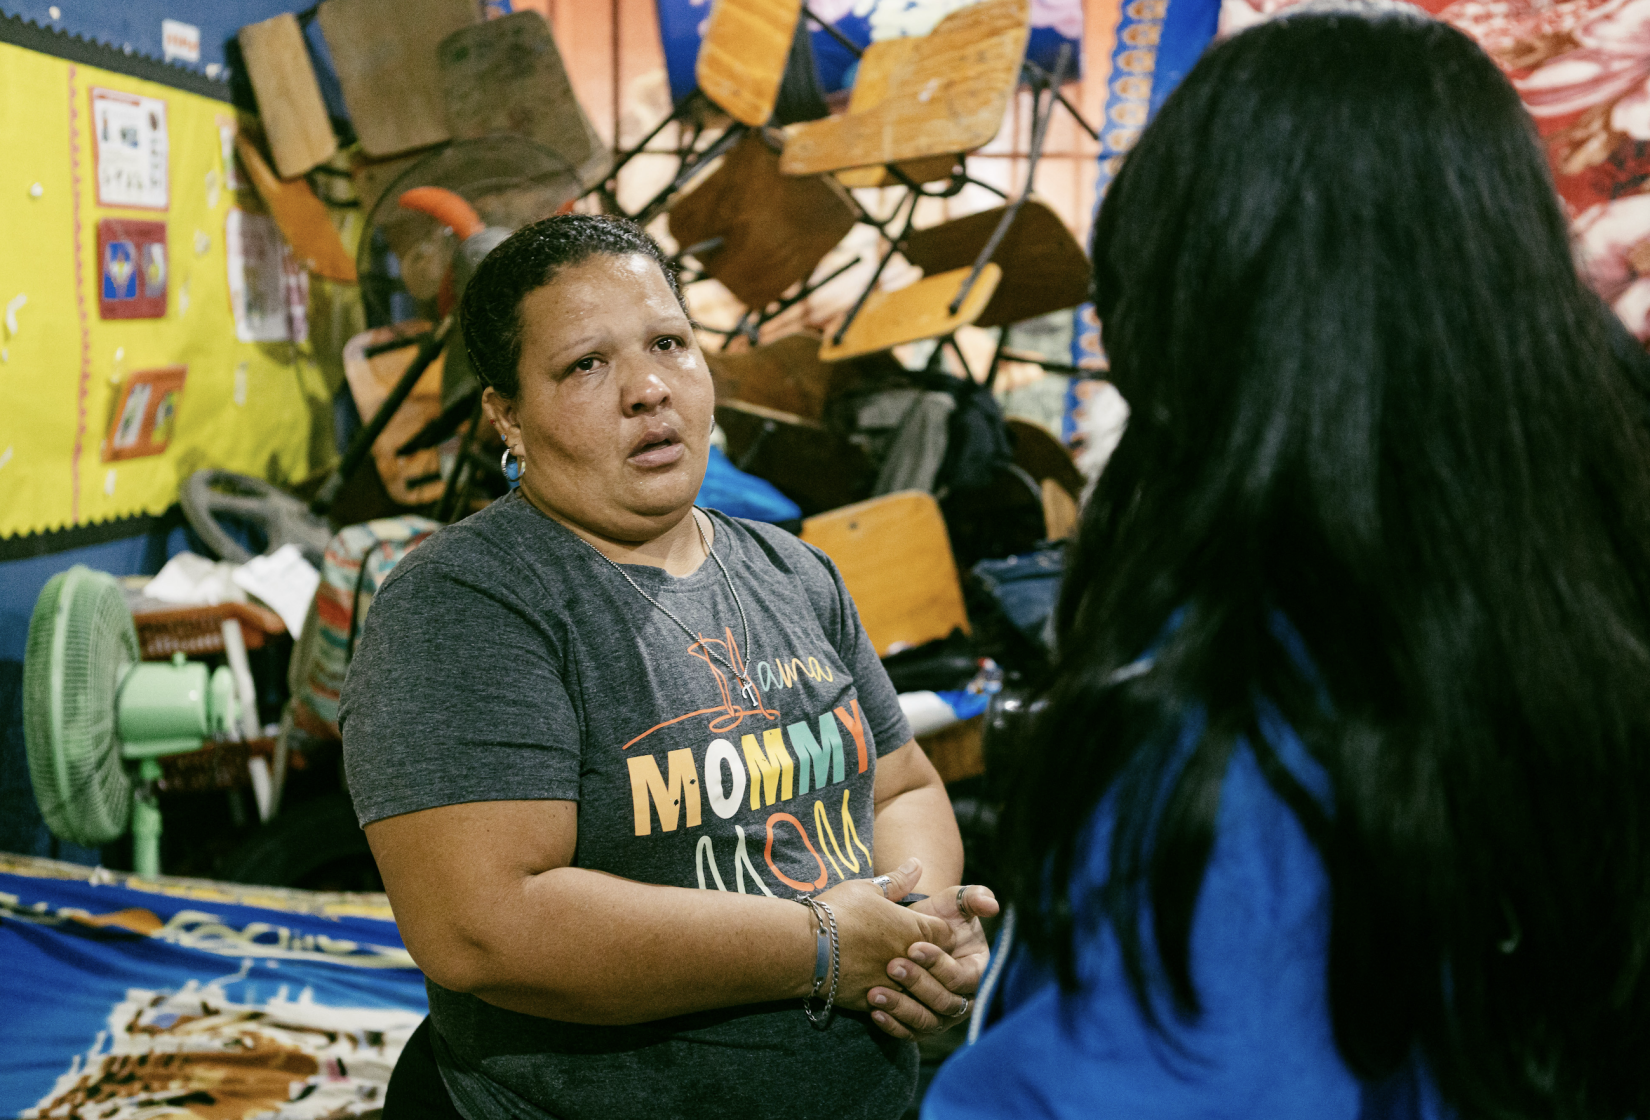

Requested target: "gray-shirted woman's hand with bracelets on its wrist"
[{"left": 813, "top": 858, "right": 952, "bottom": 1011}]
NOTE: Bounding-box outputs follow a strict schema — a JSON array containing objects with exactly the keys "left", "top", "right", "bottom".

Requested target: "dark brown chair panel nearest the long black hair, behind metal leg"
[{"left": 904, "top": 198, "right": 1089, "bottom": 327}]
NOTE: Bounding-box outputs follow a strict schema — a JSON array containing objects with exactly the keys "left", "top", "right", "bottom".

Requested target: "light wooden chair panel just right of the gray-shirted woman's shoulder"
[{"left": 802, "top": 490, "right": 969, "bottom": 656}]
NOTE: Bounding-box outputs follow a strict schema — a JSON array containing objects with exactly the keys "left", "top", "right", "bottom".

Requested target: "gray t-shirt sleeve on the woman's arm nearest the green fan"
[{"left": 338, "top": 558, "right": 581, "bottom": 825}]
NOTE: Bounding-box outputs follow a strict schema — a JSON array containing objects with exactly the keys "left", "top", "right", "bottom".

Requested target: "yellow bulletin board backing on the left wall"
[{"left": 0, "top": 43, "right": 337, "bottom": 538}]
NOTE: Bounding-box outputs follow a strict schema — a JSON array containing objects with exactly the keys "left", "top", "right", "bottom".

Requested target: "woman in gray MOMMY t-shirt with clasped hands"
[{"left": 340, "top": 216, "right": 997, "bottom": 1120}]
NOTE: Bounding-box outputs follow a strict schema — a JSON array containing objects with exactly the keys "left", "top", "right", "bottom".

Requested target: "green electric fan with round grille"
[{"left": 23, "top": 564, "right": 239, "bottom": 874}]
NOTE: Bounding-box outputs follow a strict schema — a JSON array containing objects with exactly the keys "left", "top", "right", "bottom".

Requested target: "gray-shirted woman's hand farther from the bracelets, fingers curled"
[{"left": 866, "top": 886, "right": 998, "bottom": 1038}]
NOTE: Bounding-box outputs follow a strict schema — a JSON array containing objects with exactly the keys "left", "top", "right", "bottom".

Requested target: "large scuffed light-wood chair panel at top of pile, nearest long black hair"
[{"left": 779, "top": 0, "right": 1031, "bottom": 175}]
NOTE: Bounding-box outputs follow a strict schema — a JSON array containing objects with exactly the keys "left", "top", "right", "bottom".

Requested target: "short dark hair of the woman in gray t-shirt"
[{"left": 459, "top": 214, "right": 686, "bottom": 398}]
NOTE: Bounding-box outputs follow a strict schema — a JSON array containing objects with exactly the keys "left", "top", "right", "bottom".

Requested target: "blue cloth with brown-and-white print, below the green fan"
[{"left": 0, "top": 854, "right": 427, "bottom": 1120}]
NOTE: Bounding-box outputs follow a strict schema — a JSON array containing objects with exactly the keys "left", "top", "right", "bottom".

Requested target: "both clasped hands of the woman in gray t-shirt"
[{"left": 818, "top": 859, "right": 998, "bottom": 1039}]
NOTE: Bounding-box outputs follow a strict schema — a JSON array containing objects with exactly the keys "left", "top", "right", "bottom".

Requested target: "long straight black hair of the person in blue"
[{"left": 1003, "top": 13, "right": 1650, "bottom": 1120}]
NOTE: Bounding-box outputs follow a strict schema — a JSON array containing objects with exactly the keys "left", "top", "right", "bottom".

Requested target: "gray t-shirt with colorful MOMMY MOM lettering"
[{"left": 338, "top": 495, "right": 917, "bottom": 1120}]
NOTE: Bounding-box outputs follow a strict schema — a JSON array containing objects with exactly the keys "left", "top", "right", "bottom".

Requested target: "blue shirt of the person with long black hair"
[{"left": 922, "top": 706, "right": 1449, "bottom": 1120}]
